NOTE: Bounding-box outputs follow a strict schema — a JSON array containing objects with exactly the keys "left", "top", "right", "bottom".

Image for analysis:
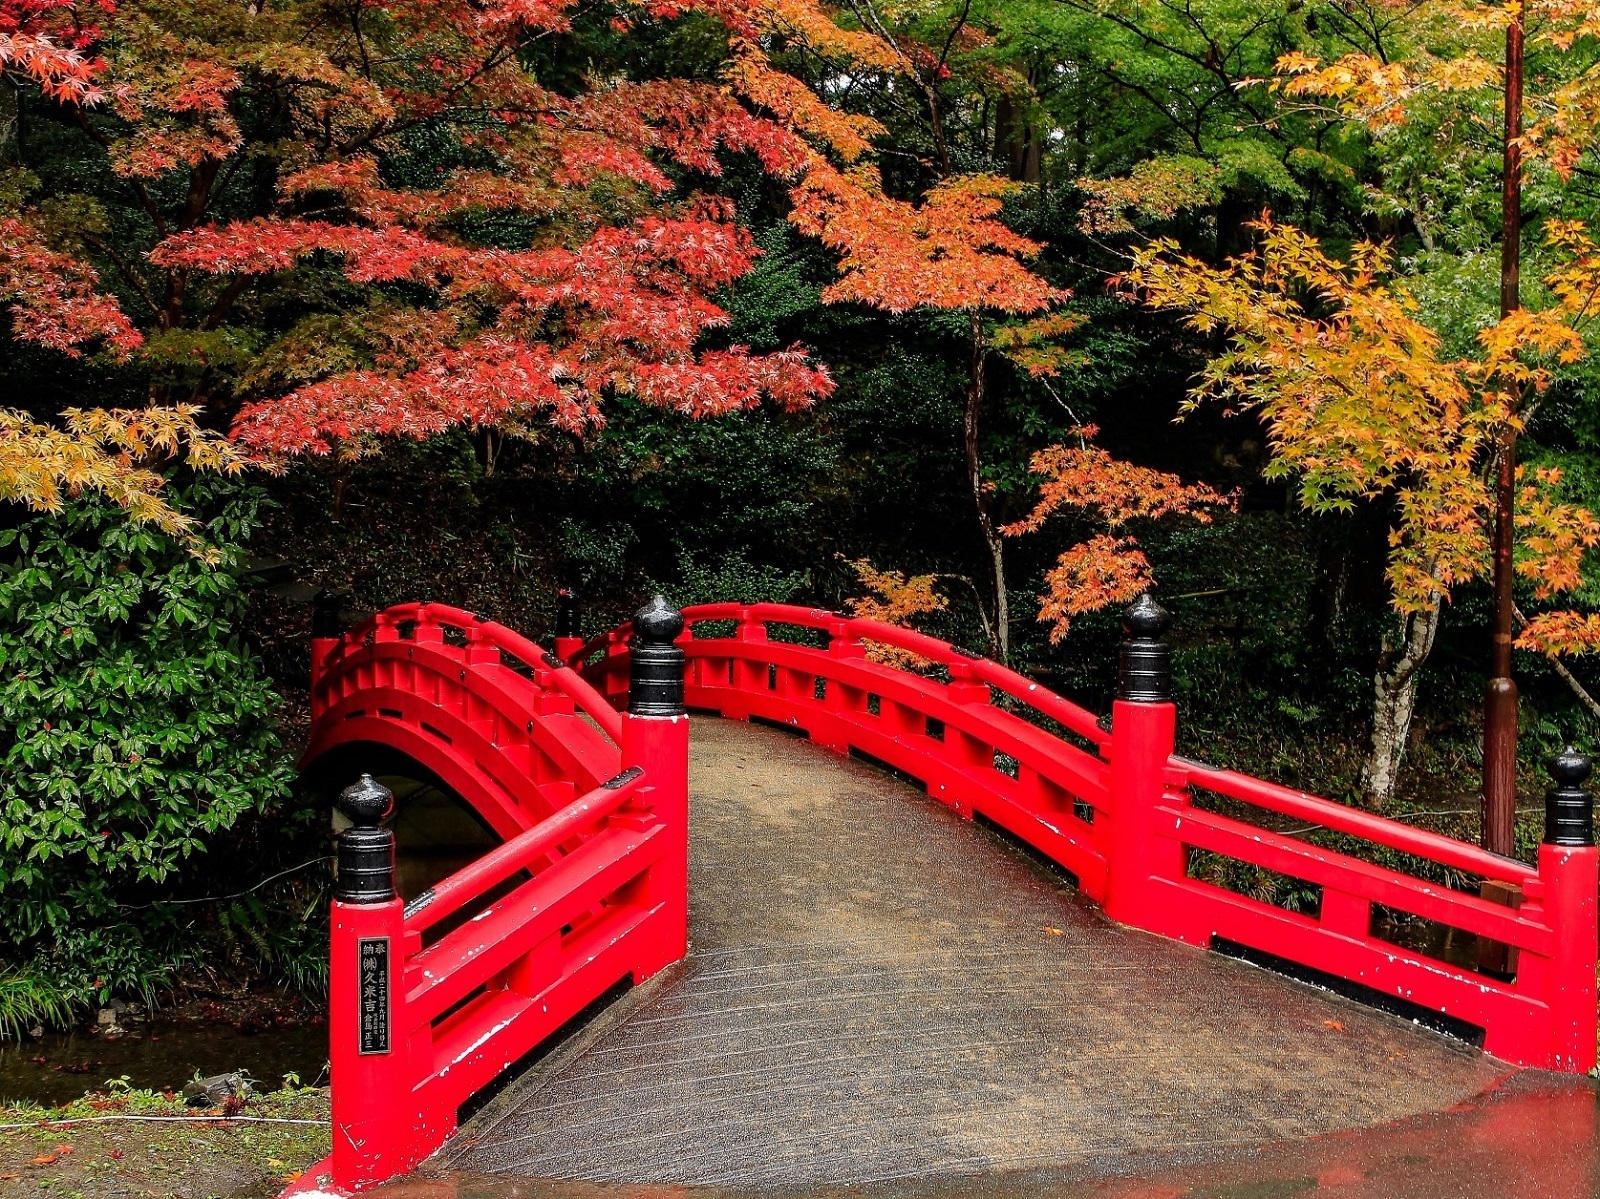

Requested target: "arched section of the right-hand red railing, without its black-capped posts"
[{"left": 568, "top": 604, "right": 1110, "bottom": 901}]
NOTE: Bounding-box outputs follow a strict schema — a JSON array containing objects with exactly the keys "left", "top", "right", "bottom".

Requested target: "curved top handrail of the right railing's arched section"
[{"left": 568, "top": 604, "right": 1110, "bottom": 748}]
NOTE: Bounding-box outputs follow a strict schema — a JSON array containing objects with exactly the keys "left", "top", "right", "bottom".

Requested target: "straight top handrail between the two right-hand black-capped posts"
[{"left": 1170, "top": 754, "right": 1539, "bottom": 888}]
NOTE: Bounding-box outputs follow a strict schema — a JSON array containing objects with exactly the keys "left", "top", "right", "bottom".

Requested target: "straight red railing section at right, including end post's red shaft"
[{"left": 1142, "top": 759, "right": 1595, "bottom": 1073}]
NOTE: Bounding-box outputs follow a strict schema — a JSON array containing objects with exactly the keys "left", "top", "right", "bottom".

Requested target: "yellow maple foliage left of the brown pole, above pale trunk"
[{"left": 1122, "top": 216, "right": 1507, "bottom": 613}]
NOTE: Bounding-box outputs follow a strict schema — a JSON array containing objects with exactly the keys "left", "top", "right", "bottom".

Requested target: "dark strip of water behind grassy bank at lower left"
[{"left": 0, "top": 1020, "right": 328, "bottom": 1105}]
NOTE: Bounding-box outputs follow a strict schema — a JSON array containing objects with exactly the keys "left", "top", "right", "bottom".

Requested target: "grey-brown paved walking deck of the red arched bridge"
[{"left": 437, "top": 717, "right": 1507, "bottom": 1189}]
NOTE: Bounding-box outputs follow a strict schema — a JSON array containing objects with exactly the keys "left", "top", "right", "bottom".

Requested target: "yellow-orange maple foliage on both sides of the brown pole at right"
[{"left": 1123, "top": 218, "right": 1600, "bottom": 650}]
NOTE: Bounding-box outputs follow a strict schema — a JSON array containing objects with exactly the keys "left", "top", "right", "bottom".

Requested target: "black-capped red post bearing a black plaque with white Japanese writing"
[{"left": 328, "top": 775, "right": 418, "bottom": 1189}]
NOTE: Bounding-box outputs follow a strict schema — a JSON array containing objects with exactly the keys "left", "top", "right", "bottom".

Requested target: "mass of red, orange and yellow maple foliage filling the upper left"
[{"left": 0, "top": 0, "right": 934, "bottom": 528}]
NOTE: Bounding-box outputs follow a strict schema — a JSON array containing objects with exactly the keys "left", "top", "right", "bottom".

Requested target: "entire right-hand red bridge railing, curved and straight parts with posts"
[{"left": 563, "top": 585, "right": 1600, "bottom": 1073}]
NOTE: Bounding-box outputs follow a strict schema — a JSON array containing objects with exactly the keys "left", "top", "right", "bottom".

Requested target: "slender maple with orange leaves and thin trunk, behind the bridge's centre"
[{"left": 755, "top": 5, "right": 1210, "bottom": 660}]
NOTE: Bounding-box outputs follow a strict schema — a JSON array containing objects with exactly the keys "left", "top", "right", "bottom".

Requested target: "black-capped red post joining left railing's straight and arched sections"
[{"left": 622, "top": 595, "right": 690, "bottom": 981}]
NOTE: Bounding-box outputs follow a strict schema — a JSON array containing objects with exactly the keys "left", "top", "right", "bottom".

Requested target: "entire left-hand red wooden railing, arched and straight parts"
[{"left": 285, "top": 605, "right": 688, "bottom": 1194}]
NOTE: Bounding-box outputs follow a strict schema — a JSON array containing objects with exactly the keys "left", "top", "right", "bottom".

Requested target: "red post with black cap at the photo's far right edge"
[{"left": 1539, "top": 749, "right": 1600, "bottom": 1074}]
